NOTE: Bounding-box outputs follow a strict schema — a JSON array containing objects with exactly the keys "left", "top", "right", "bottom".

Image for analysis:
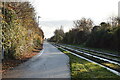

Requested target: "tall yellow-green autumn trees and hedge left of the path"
[{"left": 0, "top": 2, "right": 44, "bottom": 59}]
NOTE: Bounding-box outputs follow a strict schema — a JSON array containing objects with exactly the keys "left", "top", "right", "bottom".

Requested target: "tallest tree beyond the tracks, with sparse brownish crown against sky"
[{"left": 67, "top": 18, "right": 93, "bottom": 44}]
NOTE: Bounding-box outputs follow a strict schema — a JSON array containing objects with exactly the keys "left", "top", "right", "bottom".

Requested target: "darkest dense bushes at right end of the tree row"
[{"left": 86, "top": 25, "right": 120, "bottom": 50}]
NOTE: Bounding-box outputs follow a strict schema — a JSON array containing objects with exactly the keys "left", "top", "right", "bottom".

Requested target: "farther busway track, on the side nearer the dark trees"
[{"left": 57, "top": 44, "right": 120, "bottom": 65}]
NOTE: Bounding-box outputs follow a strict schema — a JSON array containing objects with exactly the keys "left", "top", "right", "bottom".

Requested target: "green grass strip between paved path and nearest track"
[{"left": 58, "top": 48, "right": 120, "bottom": 80}]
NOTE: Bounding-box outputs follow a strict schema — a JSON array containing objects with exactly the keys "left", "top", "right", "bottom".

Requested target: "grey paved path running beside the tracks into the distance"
[{"left": 3, "top": 42, "right": 70, "bottom": 78}]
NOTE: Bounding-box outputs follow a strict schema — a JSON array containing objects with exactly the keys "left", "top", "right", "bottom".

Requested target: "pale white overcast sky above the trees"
[{"left": 29, "top": 0, "right": 119, "bottom": 38}]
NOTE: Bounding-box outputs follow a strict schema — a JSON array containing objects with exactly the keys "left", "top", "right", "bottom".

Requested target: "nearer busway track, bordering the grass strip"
[{"left": 54, "top": 44, "right": 120, "bottom": 76}]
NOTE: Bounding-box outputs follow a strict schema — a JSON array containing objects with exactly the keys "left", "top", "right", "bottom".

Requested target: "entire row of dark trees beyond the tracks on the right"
[{"left": 48, "top": 17, "right": 120, "bottom": 51}]
